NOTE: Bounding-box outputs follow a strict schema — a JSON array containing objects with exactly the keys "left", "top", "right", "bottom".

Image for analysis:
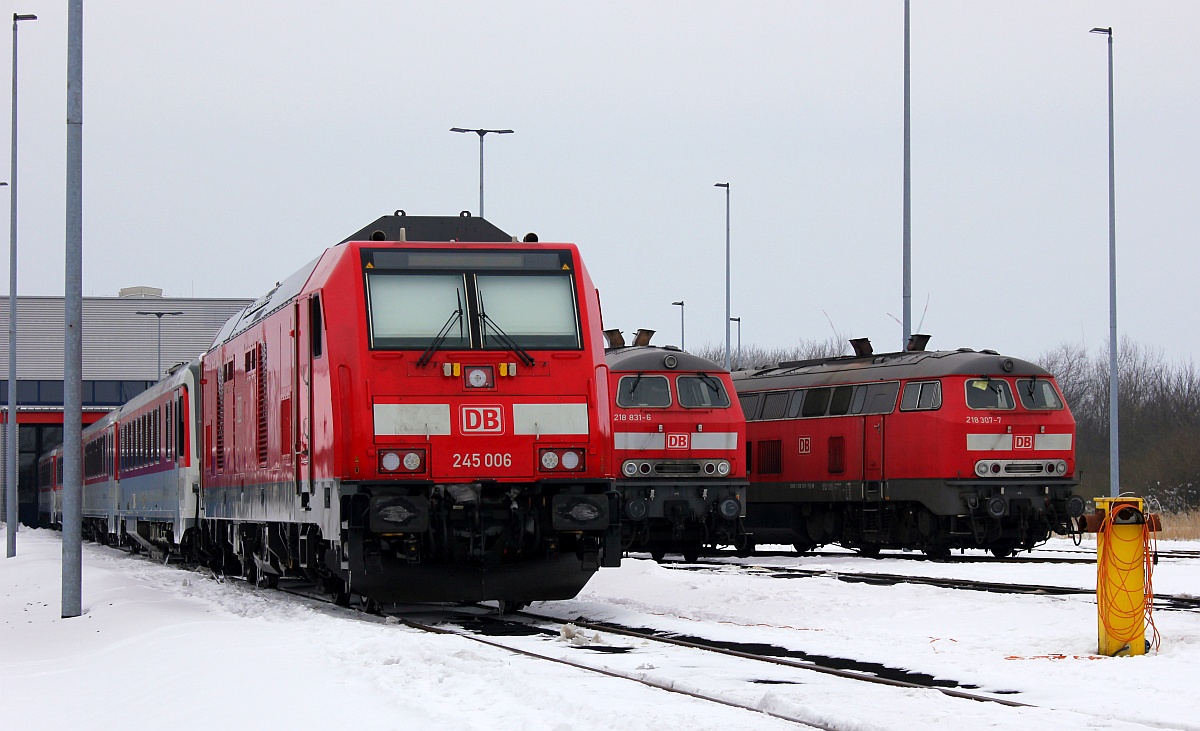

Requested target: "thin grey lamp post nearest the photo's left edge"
[{"left": 5, "top": 13, "right": 37, "bottom": 558}]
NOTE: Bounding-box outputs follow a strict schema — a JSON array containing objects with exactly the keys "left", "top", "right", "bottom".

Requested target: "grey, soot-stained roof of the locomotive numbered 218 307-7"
[{"left": 733, "top": 348, "right": 1052, "bottom": 390}]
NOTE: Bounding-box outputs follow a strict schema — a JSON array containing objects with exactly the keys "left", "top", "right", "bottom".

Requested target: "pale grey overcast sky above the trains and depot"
[{"left": 7, "top": 0, "right": 1200, "bottom": 360}]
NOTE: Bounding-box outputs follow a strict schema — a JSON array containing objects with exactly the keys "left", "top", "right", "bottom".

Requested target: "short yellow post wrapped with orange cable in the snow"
[{"left": 1096, "top": 497, "right": 1150, "bottom": 657}]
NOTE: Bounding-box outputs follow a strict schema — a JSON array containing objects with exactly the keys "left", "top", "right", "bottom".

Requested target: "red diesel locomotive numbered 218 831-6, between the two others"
[{"left": 605, "top": 330, "right": 748, "bottom": 561}]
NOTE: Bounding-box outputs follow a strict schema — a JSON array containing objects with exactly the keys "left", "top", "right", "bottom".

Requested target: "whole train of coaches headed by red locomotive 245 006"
[{"left": 43, "top": 211, "right": 620, "bottom": 607}]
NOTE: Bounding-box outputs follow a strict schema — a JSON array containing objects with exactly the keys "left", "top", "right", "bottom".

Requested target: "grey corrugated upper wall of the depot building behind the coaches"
[{"left": 0, "top": 296, "right": 253, "bottom": 381}]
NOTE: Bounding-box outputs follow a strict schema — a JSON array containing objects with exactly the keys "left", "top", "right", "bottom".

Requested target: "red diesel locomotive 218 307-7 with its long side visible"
[{"left": 733, "top": 336, "right": 1085, "bottom": 557}]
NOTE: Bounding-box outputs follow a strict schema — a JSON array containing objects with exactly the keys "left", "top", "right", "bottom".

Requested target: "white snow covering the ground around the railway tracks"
[{"left": 0, "top": 529, "right": 1200, "bottom": 731}]
